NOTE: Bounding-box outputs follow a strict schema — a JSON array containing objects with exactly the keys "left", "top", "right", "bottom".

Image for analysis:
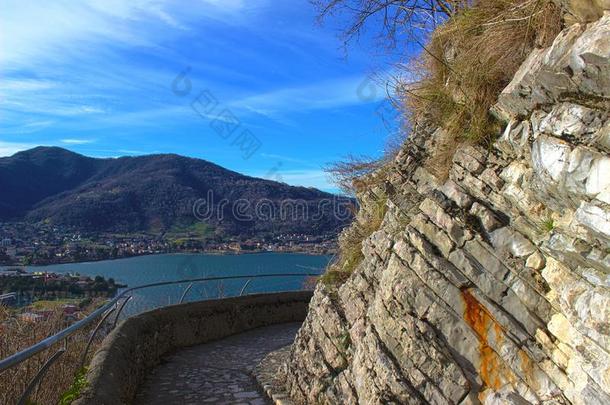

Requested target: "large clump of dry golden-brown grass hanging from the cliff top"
[{"left": 399, "top": 0, "right": 562, "bottom": 178}]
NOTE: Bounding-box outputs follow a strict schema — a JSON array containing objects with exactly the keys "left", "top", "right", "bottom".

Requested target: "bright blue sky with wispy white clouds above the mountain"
[{"left": 0, "top": 0, "right": 400, "bottom": 190}]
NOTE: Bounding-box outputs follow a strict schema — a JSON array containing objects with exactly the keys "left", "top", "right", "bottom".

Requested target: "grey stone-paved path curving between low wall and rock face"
[{"left": 136, "top": 323, "right": 301, "bottom": 405}]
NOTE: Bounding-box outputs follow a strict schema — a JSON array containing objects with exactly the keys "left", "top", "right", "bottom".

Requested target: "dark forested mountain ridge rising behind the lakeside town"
[{"left": 0, "top": 147, "right": 351, "bottom": 235}]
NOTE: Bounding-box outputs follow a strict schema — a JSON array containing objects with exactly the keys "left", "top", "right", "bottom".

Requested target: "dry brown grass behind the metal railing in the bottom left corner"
[{"left": 0, "top": 306, "right": 99, "bottom": 405}]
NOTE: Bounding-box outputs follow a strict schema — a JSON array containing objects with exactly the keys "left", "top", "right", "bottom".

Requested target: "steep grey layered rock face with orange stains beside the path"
[{"left": 283, "top": 12, "right": 610, "bottom": 405}]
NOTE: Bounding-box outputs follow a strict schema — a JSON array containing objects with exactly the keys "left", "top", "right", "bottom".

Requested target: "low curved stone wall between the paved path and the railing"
[{"left": 76, "top": 292, "right": 312, "bottom": 405}]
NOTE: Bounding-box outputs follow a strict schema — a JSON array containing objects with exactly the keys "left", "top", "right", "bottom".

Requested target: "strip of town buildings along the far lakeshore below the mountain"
[{"left": 0, "top": 222, "right": 336, "bottom": 266}]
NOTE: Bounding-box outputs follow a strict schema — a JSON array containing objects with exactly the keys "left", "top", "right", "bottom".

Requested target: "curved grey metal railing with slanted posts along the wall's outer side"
[{"left": 0, "top": 273, "right": 320, "bottom": 405}]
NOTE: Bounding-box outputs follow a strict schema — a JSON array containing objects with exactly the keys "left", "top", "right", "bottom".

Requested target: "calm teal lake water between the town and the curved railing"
[{"left": 16, "top": 253, "right": 331, "bottom": 315}]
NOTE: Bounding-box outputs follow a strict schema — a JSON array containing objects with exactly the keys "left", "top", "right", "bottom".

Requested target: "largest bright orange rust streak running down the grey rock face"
[{"left": 462, "top": 289, "right": 502, "bottom": 390}]
